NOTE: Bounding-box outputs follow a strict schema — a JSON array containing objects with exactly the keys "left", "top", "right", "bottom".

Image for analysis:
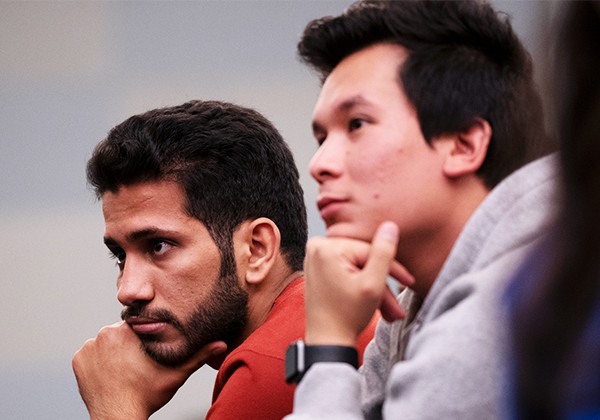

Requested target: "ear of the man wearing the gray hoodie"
[{"left": 443, "top": 118, "right": 492, "bottom": 178}]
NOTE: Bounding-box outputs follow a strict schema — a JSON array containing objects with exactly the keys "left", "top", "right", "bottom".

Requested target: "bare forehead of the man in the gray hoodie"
[{"left": 314, "top": 44, "right": 408, "bottom": 121}]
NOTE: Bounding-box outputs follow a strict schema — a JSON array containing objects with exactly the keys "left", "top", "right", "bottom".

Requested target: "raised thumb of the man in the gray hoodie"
[{"left": 364, "top": 221, "right": 398, "bottom": 279}]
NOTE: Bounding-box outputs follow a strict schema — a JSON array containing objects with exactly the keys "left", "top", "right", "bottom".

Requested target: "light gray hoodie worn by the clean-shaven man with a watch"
[{"left": 286, "top": 156, "right": 558, "bottom": 420}]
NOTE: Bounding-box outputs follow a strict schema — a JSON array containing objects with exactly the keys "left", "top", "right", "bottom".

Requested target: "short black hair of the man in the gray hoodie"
[{"left": 298, "top": 0, "right": 550, "bottom": 188}]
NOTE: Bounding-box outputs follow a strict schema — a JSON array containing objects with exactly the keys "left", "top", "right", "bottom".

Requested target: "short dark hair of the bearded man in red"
[{"left": 87, "top": 101, "right": 307, "bottom": 271}]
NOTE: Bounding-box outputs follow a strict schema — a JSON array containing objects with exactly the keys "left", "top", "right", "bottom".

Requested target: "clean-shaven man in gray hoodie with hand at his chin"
[{"left": 286, "top": 1, "right": 556, "bottom": 420}]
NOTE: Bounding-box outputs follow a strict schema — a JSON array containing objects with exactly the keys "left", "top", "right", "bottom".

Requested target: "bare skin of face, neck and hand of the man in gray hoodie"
[{"left": 305, "top": 44, "right": 491, "bottom": 346}]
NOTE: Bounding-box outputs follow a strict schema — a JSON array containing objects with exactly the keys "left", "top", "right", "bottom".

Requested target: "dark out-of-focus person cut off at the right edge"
[{"left": 507, "top": 1, "right": 600, "bottom": 420}]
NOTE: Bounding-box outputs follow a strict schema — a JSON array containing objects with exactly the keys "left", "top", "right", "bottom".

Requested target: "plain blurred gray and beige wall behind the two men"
[{"left": 0, "top": 1, "right": 556, "bottom": 420}]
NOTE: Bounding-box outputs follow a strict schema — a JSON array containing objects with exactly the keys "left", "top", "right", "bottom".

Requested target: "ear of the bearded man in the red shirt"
[{"left": 246, "top": 217, "right": 281, "bottom": 284}]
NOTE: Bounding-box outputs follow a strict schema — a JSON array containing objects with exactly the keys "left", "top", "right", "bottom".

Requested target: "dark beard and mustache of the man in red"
[{"left": 121, "top": 251, "right": 248, "bottom": 366}]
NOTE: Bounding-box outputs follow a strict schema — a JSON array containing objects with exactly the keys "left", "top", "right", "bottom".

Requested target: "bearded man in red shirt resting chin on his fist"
[{"left": 73, "top": 101, "right": 374, "bottom": 419}]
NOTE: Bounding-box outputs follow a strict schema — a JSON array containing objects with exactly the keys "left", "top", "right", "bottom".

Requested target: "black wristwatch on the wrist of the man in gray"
[{"left": 285, "top": 340, "right": 358, "bottom": 384}]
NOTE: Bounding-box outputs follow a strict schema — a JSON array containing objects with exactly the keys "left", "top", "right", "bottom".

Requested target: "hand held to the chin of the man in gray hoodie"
[{"left": 305, "top": 222, "right": 414, "bottom": 347}]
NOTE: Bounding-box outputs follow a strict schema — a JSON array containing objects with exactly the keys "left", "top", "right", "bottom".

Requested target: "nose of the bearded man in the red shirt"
[{"left": 117, "top": 256, "right": 154, "bottom": 306}]
